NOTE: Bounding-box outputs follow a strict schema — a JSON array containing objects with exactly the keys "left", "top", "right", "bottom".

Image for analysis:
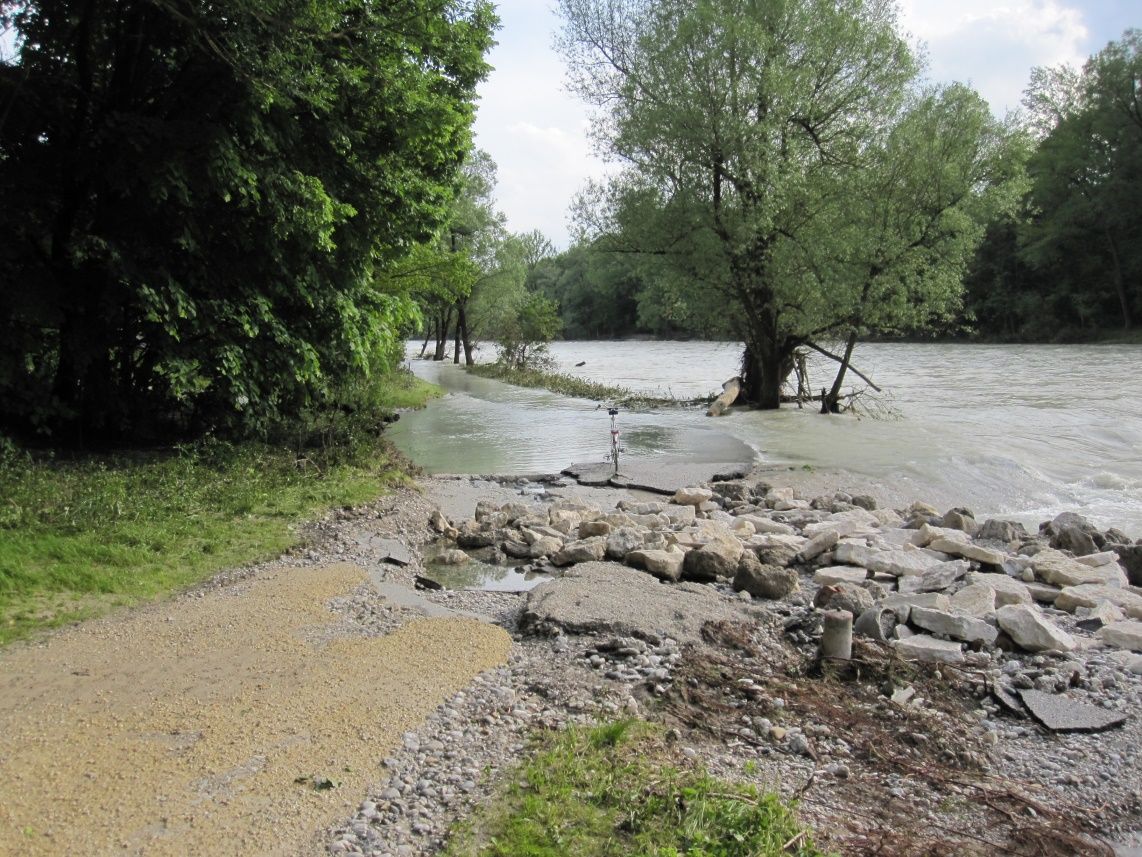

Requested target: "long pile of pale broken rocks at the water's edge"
[{"left": 434, "top": 482, "right": 1142, "bottom": 664}]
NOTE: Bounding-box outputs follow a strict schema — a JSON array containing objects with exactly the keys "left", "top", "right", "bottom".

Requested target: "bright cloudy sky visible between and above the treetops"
[{"left": 476, "top": 0, "right": 1142, "bottom": 248}]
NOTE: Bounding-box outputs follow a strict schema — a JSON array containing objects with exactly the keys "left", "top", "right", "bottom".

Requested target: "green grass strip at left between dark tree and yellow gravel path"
[{"left": 0, "top": 377, "right": 434, "bottom": 644}]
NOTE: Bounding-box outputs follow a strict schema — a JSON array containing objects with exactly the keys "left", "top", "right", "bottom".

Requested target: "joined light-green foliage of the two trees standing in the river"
[{"left": 560, "top": 0, "right": 1019, "bottom": 407}]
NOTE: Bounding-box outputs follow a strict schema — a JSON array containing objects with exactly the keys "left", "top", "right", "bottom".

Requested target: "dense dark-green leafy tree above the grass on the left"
[{"left": 0, "top": 0, "right": 496, "bottom": 440}]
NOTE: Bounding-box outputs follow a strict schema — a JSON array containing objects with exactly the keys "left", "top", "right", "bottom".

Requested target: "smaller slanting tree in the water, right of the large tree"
[{"left": 815, "top": 85, "right": 1027, "bottom": 407}]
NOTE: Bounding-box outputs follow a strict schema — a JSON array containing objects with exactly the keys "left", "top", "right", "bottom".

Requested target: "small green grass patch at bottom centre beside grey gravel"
[{"left": 444, "top": 720, "right": 822, "bottom": 857}]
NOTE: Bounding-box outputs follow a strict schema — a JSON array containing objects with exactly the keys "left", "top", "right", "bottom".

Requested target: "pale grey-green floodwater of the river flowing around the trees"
[{"left": 392, "top": 342, "right": 1142, "bottom": 538}]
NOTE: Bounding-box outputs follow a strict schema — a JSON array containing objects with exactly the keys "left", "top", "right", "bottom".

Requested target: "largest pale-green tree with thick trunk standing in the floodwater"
[{"left": 560, "top": 0, "right": 1014, "bottom": 408}]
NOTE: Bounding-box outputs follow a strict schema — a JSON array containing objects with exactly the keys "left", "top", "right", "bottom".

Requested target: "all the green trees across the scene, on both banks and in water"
[{"left": 0, "top": 0, "right": 1142, "bottom": 442}]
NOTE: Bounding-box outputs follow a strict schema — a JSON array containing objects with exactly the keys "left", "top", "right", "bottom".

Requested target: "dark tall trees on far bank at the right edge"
[{"left": 968, "top": 30, "right": 1142, "bottom": 339}]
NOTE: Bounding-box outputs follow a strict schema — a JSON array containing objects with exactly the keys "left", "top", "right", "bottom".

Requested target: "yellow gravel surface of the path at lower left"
[{"left": 0, "top": 564, "right": 510, "bottom": 856}]
